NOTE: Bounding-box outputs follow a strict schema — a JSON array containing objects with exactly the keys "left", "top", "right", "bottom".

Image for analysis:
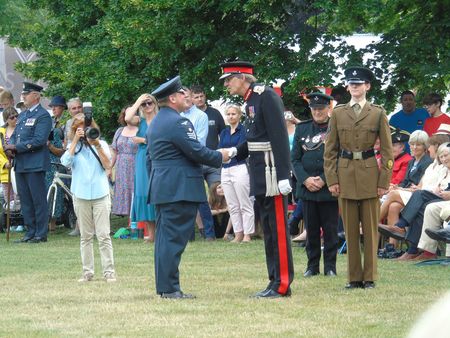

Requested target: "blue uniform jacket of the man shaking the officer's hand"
[{"left": 147, "top": 107, "right": 222, "bottom": 204}]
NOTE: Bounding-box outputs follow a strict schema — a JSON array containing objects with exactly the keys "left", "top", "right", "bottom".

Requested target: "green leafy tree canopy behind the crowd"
[{"left": 0, "top": 0, "right": 450, "bottom": 138}]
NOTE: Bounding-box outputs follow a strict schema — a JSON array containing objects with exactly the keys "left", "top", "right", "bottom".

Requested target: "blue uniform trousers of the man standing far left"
[{"left": 16, "top": 171, "right": 48, "bottom": 238}]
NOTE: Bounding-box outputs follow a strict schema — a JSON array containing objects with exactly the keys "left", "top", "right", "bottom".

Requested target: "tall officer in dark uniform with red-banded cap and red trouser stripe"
[{"left": 220, "top": 61, "right": 294, "bottom": 298}]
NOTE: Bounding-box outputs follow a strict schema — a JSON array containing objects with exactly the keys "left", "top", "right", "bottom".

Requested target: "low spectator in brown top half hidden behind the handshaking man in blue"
[{"left": 208, "top": 182, "right": 233, "bottom": 241}]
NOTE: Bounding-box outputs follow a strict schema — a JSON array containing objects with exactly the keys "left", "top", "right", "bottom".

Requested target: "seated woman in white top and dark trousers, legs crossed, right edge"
[{"left": 380, "top": 142, "right": 450, "bottom": 260}]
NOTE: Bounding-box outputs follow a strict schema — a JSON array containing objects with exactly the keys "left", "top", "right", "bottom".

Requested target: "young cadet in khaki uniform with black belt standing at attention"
[{"left": 324, "top": 67, "right": 393, "bottom": 289}]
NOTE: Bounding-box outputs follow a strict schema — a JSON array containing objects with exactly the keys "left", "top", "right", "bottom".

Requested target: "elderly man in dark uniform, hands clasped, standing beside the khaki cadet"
[{"left": 291, "top": 93, "right": 339, "bottom": 277}]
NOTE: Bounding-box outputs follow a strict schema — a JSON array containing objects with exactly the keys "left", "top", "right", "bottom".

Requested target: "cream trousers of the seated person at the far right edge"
[{"left": 417, "top": 201, "right": 450, "bottom": 256}]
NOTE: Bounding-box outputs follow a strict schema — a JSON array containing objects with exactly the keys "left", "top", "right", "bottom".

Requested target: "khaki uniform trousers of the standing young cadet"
[{"left": 339, "top": 197, "right": 380, "bottom": 282}]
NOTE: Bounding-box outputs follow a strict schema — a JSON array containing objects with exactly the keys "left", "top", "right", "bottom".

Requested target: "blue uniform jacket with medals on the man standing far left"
[{"left": 11, "top": 104, "right": 52, "bottom": 173}]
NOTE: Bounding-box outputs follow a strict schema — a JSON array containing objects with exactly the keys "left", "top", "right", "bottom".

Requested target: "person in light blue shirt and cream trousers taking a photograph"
[{"left": 61, "top": 102, "right": 116, "bottom": 282}]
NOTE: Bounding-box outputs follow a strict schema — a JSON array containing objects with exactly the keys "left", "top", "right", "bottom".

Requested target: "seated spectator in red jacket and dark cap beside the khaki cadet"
[{"left": 391, "top": 129, "right": 412, "bottom": 188}]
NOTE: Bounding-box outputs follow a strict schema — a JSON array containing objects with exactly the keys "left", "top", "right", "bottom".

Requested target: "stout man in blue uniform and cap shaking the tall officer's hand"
[{"left": 147, "top": 76, "right": 228, "bottom": 299}]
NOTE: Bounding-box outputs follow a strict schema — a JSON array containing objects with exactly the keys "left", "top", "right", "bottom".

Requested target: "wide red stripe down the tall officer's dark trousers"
[{"left": 274, "top": 195, "right": 289, "bottom": 295}]
